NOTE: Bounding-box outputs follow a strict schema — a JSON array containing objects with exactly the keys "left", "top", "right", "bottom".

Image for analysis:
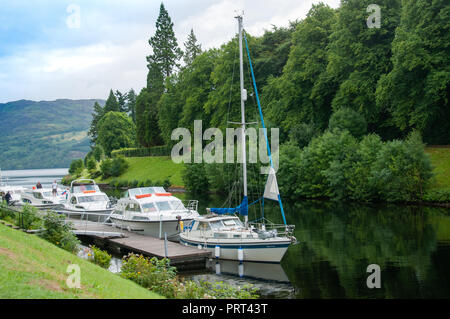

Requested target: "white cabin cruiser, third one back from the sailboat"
[{"left": 16, "top": 187, "right": 65, "bottom": 209}]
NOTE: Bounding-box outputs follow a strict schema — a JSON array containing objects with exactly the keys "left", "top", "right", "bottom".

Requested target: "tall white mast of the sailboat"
[{"left": 236, "top": 15, "right": 248, "bottom": 227}]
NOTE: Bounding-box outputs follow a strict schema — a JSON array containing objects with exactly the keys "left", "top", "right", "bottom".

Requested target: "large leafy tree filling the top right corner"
[{"left": 377, "top": 0, "right": 450, "bottom": 144}]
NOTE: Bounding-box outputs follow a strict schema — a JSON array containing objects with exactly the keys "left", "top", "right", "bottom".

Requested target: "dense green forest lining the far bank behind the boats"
[{"left": 86, "top": 0, "right": 450, "bottom": 201}]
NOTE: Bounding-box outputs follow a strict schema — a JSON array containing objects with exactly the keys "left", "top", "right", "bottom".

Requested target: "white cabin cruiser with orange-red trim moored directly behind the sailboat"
[{"left": 110, "top": 187, "right": 199, "bottom": 240}]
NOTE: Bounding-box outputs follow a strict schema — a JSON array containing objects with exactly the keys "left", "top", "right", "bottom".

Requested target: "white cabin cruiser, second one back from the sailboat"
[{"left": 57, "top": 179, "right": 114, "bottom": 223}]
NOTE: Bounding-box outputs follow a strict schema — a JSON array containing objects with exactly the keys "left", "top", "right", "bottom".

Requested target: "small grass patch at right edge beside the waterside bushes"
[{"left": 426, "top": 147, "right": 450, "bottom": 189}]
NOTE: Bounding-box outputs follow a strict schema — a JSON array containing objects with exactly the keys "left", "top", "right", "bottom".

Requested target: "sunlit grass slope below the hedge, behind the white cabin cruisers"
[{"left": 96, "top": 156, "right": 184, "bottom": 186}]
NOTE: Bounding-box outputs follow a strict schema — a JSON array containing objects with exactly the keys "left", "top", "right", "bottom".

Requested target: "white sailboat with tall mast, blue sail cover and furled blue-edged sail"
[{"left": 180, "top": 15, "right": 296, "bottom": 263}]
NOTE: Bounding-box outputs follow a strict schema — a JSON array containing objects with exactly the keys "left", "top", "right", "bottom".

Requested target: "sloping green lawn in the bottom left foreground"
[{"left": 0, "top": 224, "right": 162, "bottom": 299}]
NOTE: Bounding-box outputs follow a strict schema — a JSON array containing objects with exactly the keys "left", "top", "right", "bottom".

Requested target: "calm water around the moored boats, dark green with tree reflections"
[{"left": 4, "top": 170, "right": 450, "bottom": 298}]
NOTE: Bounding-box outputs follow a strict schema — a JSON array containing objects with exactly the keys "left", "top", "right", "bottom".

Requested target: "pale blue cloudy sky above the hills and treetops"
[{"left": 0, "top": 0, "right": 340, "bottom": 103}]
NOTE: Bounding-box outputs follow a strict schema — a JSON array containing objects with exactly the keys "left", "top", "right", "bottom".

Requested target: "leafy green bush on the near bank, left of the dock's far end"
[{"left": 39, "top": 211, "right": 80, "bottom": 253}]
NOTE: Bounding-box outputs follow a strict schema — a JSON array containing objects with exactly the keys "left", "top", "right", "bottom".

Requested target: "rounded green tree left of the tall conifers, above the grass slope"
[{"left": 97, "top": 112, "right": 136, "bottom": 155}]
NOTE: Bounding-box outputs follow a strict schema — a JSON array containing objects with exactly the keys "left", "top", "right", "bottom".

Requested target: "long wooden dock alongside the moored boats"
[{"left": 73, "top": 222, "right": 211, "bottom": 270}]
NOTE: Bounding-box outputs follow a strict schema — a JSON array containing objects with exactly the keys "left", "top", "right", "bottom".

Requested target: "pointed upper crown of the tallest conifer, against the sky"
[{"left": 147, "top": 3, "right": 183, "bottom": 78}]
